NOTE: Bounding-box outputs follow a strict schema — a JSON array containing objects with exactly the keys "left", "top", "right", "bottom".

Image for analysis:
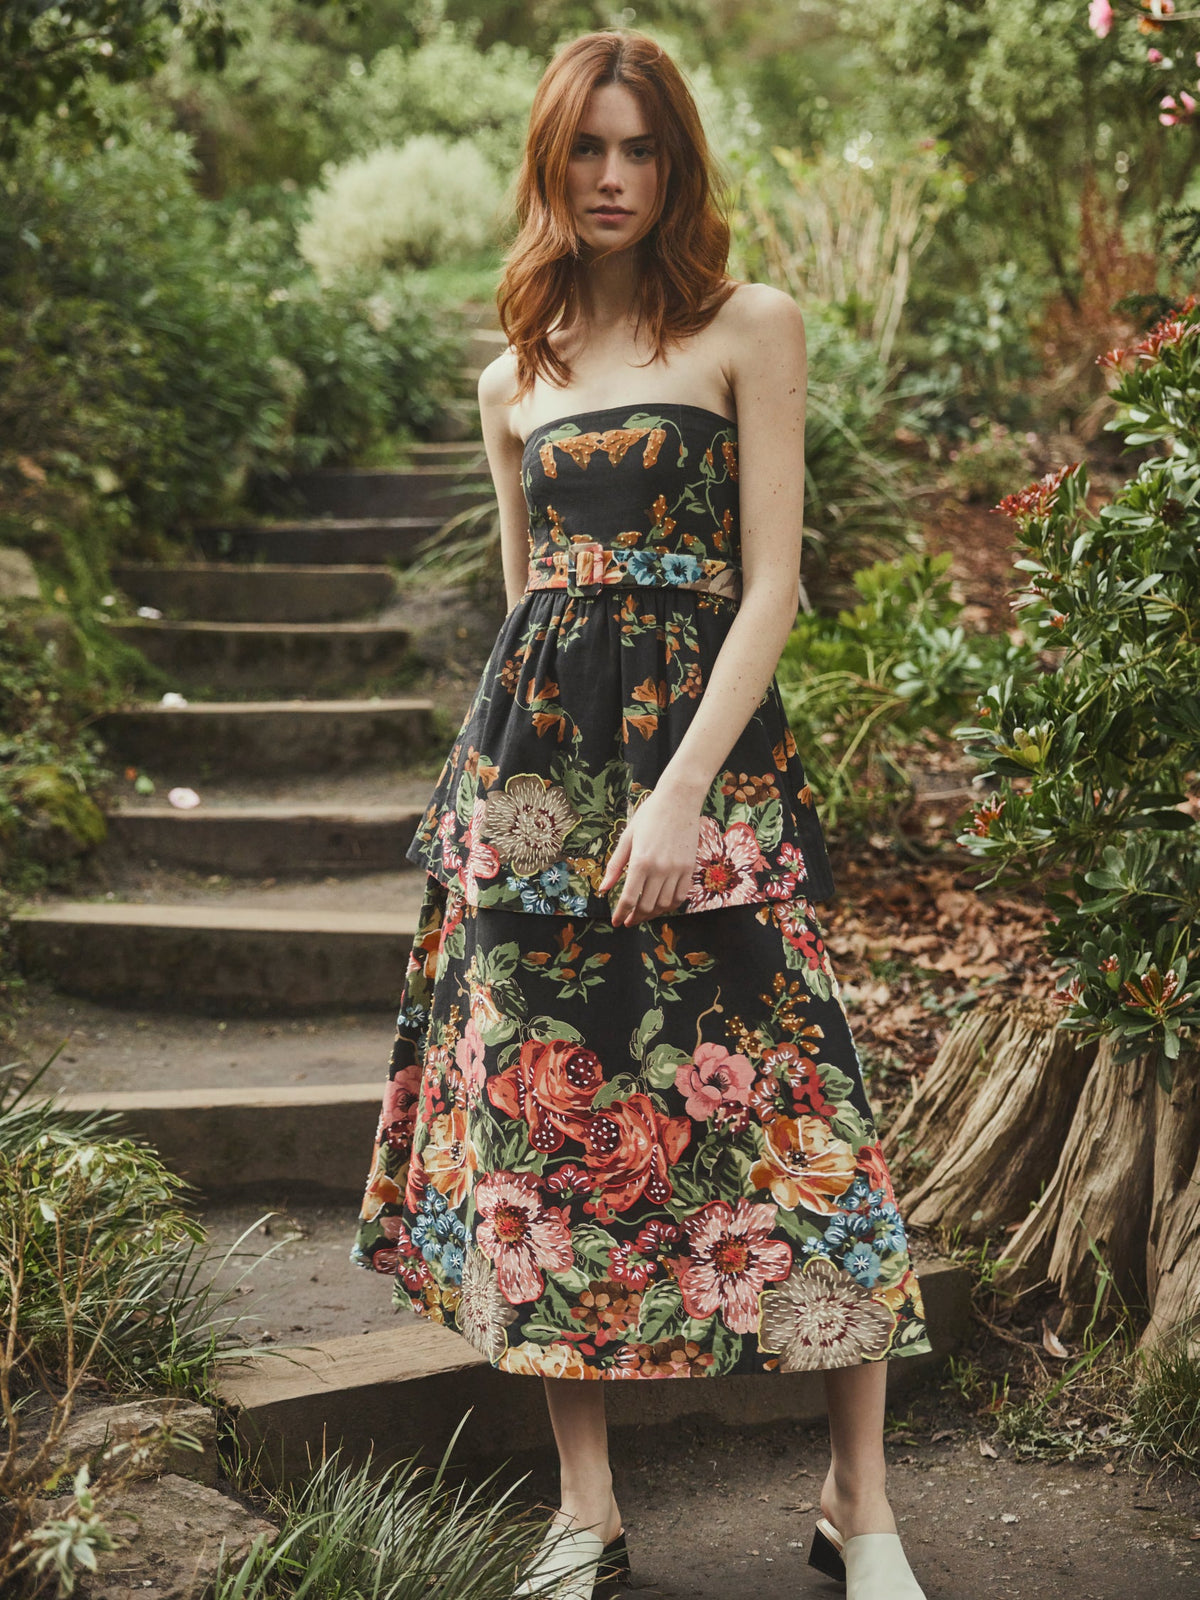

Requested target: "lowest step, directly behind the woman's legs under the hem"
[{"left": 216, "top": 1258, "right": 971, "bottom": 1480}]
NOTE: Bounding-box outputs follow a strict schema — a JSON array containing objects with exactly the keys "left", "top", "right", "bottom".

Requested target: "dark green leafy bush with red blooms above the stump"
[{"left": 960, "top": 298, "right": 1200, "bottom": 1085}]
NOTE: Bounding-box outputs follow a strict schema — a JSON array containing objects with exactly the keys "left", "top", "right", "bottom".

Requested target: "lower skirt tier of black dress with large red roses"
[{"left": 354, "top": 877, "right": 931, "bottom": 1379}]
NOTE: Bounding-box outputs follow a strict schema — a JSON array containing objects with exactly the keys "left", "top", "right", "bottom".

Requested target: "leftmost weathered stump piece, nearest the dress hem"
[{"left": 888, "top": 998, "right": 1094, "bottom": 1238}]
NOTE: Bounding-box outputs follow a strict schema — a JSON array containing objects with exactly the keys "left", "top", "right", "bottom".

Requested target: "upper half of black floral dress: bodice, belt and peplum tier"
[{"left": 408, "top": 405, "right": 834, "bottom": 917}]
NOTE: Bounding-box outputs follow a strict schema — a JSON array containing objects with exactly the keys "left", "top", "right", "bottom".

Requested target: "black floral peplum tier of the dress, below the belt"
[{"left": 406, "top": 582, "right": 834, "bottom": 920}]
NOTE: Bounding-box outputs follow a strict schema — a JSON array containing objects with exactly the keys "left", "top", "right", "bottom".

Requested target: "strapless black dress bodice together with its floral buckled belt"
[{"left": 522, "top": 403, "right": 741, "bottom": 598}]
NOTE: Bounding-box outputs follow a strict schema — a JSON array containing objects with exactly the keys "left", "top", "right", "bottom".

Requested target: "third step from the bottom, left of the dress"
[{"left": 13, "top": 901, "right": 414, "bottom": 1016}]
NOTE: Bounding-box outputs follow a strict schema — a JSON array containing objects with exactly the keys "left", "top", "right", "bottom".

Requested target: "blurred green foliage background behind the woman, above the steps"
[{"left": 0, "top": 0, "right": 1197, "bottom": 872}]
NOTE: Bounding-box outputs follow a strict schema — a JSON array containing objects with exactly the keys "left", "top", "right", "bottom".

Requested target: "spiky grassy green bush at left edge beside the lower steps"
[{"left": 0, "top": 1051, "right": 262, "bottom": 1595}]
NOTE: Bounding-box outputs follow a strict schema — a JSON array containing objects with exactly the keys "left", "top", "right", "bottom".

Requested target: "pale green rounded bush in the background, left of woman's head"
[{"left": 298, "top": 133, "right": 501, "bottom": 283}]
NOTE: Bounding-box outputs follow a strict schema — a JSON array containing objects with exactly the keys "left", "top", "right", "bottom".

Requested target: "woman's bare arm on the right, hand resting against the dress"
[{"left": 600, "top": 283, "right": 808, "bottom": 926}]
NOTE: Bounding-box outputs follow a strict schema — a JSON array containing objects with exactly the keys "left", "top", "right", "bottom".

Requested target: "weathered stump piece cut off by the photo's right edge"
[{"left": 1139, "top": 1050, "right": 1200, "bottom": 1355}]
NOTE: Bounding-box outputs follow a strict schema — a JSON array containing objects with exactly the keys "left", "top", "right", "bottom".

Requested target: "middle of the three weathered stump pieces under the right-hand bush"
[{"left": 997, "top": 1038, "right": 1160, "bottom": 1336}]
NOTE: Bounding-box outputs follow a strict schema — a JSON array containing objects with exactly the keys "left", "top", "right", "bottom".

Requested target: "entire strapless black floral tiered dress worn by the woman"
[{"left": 352, "top": 405, "right": 931, "bottom": 1379}]
